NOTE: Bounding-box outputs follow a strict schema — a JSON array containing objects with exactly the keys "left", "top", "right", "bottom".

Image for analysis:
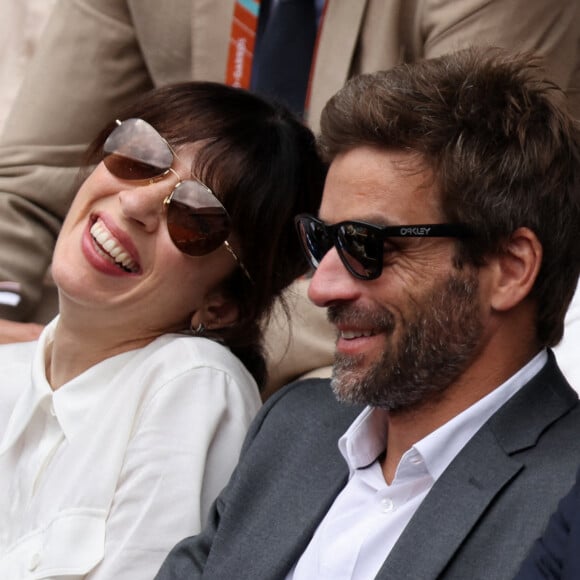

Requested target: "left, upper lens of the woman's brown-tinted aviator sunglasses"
[{"left": 103, "top": 119, "right": 173, "bottom": 180}]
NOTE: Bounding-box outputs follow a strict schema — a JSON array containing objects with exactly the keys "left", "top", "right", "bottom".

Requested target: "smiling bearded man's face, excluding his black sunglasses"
[{"left": 309, "top": 148, "right": 483, "bottom": 412}]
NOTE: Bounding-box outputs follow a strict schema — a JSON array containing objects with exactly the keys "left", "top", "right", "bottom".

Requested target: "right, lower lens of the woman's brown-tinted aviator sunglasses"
[{"left": 167, "top": 181, "right": 231, "bottom": 256}]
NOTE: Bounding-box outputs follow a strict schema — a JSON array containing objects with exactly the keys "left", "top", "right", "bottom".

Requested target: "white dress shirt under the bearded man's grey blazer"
[{"left": 287, "top": 351, "right": 547, "bottom": 580}]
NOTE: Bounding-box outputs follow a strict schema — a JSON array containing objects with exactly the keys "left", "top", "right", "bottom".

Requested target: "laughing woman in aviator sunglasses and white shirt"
[{"left": 0, "top": 83, "right": 324, "bottom": 580}]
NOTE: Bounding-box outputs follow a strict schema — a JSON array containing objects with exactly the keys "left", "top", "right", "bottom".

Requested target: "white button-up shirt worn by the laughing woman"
[{"left": 0, "top": 320, "right": 260, "bottom": 580}]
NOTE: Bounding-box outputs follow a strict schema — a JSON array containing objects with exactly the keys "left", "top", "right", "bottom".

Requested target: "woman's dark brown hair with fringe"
[{"left": 87, "top": 82, "right": 326, "bottom": 387}]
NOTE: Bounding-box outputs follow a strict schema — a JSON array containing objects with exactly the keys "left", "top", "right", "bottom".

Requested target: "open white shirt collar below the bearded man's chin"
[{"left": 338, "top": 349, "right": 548, "bottom": 480}]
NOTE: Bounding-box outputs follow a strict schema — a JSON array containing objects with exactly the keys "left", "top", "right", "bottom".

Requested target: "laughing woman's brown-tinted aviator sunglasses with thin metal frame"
[{"left": 103, "top": 119, "right": 252, "bottom": 281}]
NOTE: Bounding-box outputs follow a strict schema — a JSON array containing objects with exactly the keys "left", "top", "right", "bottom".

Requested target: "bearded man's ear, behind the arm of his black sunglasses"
[{"left": 491, "top": 228, "right": 542, "bottom": 311}]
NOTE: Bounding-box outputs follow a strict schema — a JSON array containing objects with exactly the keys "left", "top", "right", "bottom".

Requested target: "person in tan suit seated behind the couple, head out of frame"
[{"left": 0, "top": 0, "right": 580, "bottom": 394}]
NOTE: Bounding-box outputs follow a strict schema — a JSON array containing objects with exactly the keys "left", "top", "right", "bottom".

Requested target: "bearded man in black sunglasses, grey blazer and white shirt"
[{"left": 157, "top": 49, "right": 580, "bottom": 580}]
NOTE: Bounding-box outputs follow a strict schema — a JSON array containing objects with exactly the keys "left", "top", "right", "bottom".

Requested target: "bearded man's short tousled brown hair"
[{"left": 320, "top": 47, "right": 580, "bottom": 346}]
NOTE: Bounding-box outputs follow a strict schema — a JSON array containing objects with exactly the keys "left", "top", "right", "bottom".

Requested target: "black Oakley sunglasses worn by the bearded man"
[{"left": 295, "top": 214, "right": 471, "bottom": 280}]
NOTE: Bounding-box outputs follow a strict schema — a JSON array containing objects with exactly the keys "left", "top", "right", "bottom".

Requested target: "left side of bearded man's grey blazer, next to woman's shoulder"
[{"left": 155, "top": 379, "right": 362, "bottom": 580}]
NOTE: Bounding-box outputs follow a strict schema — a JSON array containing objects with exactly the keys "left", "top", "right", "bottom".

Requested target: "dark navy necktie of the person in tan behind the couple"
[{"left": 250, "top": 0, "right": 316, "bottom": 115}]
